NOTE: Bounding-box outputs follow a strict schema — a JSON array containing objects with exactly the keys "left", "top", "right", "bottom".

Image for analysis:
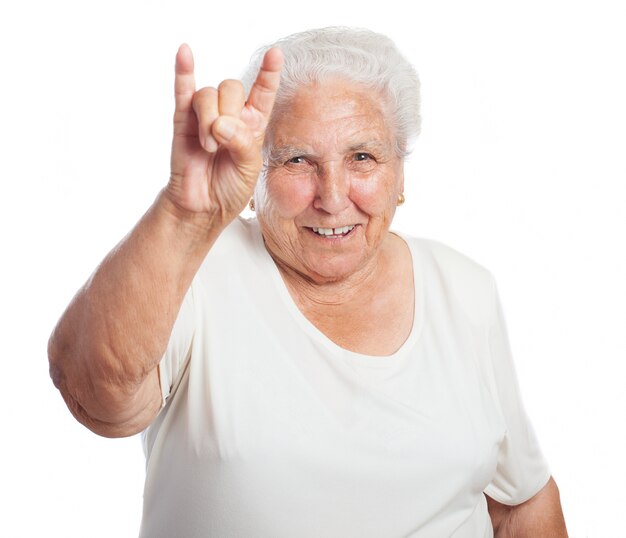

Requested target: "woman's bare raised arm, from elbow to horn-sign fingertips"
[{"left": 48, "top": 42, "right": 282, "bottom": 437}]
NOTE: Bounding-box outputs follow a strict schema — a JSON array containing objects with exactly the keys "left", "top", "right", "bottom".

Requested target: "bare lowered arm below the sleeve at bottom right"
[{"left": 487, "top": 477, "right": 567, "bottom": 538}]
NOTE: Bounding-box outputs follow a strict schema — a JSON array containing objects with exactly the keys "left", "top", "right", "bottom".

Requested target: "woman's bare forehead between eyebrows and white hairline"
[{"left": 268, "top": 79, "right": 393, "bottom": 149}]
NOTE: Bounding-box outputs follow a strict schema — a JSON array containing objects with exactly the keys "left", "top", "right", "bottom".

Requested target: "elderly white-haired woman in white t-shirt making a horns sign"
[{"left": 49, "top": 28, "right": 565, "bottom": 538}]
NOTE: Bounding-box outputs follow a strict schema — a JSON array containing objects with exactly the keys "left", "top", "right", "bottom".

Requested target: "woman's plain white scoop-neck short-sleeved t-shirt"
[{"left": 141, "top": 219, "right": 550, "bottom": 538}]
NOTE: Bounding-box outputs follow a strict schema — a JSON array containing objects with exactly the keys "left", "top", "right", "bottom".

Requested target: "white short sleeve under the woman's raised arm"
[{"left": 159, "top": 285, "right": 195, "bottom": 407}]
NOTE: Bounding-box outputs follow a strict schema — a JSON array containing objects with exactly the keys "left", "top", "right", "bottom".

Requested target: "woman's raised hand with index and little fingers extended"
[{"left": 165, "top": 45, "right": 283, "bottom": 221}]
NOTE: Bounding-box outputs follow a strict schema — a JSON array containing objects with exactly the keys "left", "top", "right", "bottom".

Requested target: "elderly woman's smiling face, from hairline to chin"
[{"left": 256, "top": 79, "right": 403, "bottom": 283}]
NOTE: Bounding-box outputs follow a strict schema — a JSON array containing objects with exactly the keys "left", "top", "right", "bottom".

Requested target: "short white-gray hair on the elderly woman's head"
[{"left": 242, "top": 26, "right": 421, "bottom": 157}]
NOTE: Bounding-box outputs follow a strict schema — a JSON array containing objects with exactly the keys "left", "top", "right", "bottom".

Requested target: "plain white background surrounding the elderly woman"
[{"left": 0, "top": 0, "right": 626, "bottom": 538}]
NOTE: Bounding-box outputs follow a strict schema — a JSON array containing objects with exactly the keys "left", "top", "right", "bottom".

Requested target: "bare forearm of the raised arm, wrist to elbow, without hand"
[{"left": 49, "top": 188, "right": 228, "bottom": 435}]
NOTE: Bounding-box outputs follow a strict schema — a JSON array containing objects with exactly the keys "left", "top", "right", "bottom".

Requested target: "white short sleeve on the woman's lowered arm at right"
[{"left": 485, "top": 285, "right": 550, "bottom": 506}]
